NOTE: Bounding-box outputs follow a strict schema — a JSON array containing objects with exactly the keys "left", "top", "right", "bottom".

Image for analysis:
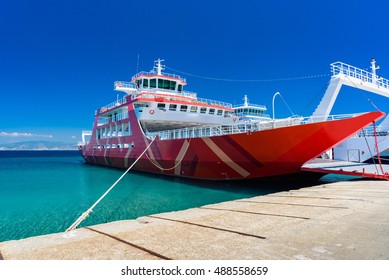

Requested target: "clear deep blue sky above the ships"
[{"left": 0, "top": 0, "right": 389, "bottom": 143}]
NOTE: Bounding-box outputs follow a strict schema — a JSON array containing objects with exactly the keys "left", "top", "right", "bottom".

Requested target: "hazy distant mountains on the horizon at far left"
[{"left": 0, "top": 141, "right": 77, "bottom": 150}]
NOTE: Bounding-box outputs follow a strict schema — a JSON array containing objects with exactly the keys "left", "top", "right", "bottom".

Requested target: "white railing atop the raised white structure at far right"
[{"left": 331, "top": 61, "right": 389, "bottom": 89}]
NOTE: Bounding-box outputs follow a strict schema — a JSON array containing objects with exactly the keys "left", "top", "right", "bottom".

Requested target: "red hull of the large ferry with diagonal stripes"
[{"left": 80, "top": 112, "right": 384, "bottom": 180}]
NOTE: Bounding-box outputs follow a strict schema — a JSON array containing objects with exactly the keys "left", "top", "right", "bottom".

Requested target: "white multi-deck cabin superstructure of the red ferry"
[{"left": 95, "top": 60, "right": 237, "bottom": 136}]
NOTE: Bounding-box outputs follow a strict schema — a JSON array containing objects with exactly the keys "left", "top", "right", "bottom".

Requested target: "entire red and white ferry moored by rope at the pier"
[{"left": 79, "top": 59, "right": 384, "bottom": 180}]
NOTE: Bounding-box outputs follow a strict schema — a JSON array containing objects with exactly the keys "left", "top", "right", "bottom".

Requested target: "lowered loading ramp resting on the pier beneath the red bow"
[{"left": 301, "top": 159, "right": 389, "bottom": 180}]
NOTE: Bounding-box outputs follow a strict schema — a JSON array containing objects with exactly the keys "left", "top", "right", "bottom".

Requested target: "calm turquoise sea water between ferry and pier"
[{"left": 0, "top": 151, "right": 346, "bottom": 242}]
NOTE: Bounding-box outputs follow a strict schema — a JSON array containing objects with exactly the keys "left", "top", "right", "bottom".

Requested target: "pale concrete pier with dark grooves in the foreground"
[{"left": 0, "top": 180, "right": 389, "bottom": 260}]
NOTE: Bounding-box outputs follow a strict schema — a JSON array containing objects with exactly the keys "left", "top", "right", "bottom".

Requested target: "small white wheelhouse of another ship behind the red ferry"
[{"left": 234, "top": 95, "right": 271, "bottom": 122}]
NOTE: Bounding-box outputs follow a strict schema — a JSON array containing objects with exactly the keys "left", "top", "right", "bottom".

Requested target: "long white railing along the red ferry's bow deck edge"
[{"left": 147, "top": 114, "right": 359, "bottom": 140}]
